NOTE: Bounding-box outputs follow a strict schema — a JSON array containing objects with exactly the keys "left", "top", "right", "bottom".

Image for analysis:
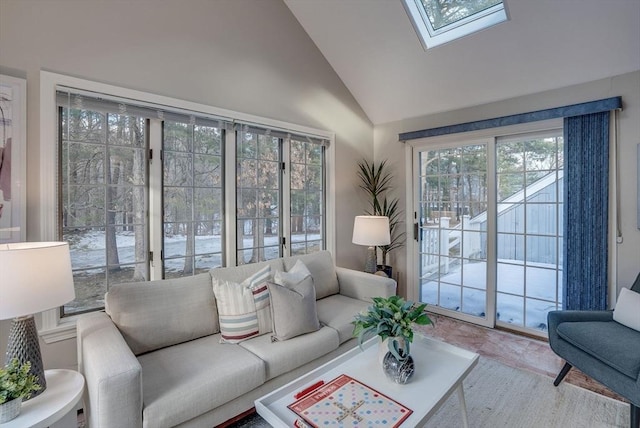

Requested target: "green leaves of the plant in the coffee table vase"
[{"left": 353, "top": 296, "right": 433, "bottom": 360}]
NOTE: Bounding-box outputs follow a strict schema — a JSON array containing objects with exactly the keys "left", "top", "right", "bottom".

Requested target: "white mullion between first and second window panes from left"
[{"left": 147, "top": 119, "right": 163, "bottom": 280}]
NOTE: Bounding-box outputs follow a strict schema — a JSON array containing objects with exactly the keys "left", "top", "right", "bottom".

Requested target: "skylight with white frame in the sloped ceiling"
[{"left": 402, "top": 0, "right": 507, "bottom": 49}]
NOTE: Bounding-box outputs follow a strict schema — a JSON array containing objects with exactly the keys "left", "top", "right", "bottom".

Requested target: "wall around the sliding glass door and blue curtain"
[{"left": 374, "top": 71, "right": 640, "bottom": 300}]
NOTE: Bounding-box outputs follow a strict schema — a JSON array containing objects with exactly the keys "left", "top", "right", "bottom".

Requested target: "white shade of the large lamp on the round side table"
[{"left": 0, "top": 242, "right": 75, "bottom": 320}]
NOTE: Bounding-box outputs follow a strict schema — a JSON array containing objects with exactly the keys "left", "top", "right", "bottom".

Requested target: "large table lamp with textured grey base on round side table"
[{"left": 0, "top": 242, "right": 75, "bottom": 398}]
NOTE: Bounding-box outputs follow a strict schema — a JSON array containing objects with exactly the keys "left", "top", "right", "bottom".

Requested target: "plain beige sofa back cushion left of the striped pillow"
[{"left": 105, "top": 273, "right": 220, "bottom": 355}]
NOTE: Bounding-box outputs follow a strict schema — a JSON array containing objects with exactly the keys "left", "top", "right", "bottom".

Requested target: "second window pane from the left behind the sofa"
[{"left": 162, "top": 120, "right": 223, "bottom": 277}]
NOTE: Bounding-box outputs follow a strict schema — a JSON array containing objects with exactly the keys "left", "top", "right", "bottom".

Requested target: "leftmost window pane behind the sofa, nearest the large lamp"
[{"left": 59, "top": 107, "right": 148, "bottom": 315}]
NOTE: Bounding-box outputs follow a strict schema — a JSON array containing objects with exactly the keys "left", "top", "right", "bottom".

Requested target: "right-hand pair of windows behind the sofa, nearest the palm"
[{"left": 236, "top": 127, "right": 326, "bottom": 264}]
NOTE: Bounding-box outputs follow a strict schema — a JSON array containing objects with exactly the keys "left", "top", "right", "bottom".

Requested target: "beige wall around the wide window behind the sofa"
[{"left": 0, "top": 0, "right": 373, "bottom": 368}]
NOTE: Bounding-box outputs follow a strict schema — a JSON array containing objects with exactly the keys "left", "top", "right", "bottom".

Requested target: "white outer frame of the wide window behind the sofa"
[{"left": 37, "top": 71, "right": 336, "bottom": 343}]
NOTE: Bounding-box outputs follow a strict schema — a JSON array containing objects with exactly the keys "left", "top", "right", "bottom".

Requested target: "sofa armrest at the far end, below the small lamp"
[{"left": 336, "top": 266, "right": 397, "bottom": 302}]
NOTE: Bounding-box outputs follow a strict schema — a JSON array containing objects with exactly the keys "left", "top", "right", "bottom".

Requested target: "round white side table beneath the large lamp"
[{"left": 0, "top": 369, "right": 84, "bottom": 428}]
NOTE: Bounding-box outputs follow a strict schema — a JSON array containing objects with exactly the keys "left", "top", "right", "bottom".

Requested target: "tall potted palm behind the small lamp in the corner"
[{"left": 357, "top": 159, "right": 406, "bottom": 277}]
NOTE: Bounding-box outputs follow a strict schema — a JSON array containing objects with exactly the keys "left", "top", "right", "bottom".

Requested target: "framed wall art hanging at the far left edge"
[{"left": 0, "top": 74, "right": 27, "bottom": 243}]
